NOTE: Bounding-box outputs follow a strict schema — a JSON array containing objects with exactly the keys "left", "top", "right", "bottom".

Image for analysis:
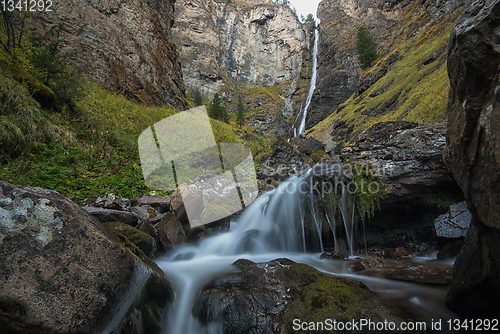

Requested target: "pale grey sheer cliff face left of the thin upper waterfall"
[{"left": 173, "top": 0, "right": 305, "bottom": 96}]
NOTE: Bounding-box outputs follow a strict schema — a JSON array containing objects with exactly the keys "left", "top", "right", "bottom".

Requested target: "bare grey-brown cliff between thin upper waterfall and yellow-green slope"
[{"left": 306, "top": 0, "right": 410, "bottom": 129}]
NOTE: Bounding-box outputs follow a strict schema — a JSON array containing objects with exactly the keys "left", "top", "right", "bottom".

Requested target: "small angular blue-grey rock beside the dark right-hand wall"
[{"left": 434, "top": 201, "right": 472, "bottom": 239}]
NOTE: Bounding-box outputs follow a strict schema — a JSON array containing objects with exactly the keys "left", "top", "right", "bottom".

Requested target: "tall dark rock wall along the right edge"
[{"left": 444, "top": 1, "right": 500, "bottom": 319}]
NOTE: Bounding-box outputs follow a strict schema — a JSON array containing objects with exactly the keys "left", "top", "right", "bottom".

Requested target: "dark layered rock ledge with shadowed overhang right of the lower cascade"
[{"left": 341, "top": 122, "right": 463, "bottom": 248}]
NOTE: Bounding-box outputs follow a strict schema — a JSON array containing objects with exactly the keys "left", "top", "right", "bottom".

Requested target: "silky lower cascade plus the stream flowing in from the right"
[{"left": 157, "top": 169, "right": 458, "bottom": 334}]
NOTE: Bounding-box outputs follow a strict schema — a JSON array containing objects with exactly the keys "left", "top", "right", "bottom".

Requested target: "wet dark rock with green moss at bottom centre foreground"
[{"left": 193, "top": 259, "right": 420, "bottom": 334}]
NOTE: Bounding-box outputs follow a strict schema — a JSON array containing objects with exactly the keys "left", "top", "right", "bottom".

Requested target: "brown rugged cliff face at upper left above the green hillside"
[{"left": 33, "top": 0, "right": 185, "bottom": 108}]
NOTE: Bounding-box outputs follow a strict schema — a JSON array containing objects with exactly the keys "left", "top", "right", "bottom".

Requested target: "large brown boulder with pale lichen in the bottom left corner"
[{"left": 0, "top": 182, "right": 173, "bottom": 334}]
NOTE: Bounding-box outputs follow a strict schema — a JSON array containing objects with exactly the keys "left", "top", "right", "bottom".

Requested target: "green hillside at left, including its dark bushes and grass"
[{"left": 0, "top": 15, "right": 271, "bottom": 200}]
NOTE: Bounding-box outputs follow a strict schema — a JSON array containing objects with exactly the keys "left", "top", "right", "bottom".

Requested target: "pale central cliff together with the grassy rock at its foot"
[{"left": 173, "top": 0, "right": 306, "bottom": 137}]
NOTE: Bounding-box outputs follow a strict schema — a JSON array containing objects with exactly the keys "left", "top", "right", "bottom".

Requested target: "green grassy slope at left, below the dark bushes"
[{"left": 0, "top": 72, "right": 270, "bottom": 200}]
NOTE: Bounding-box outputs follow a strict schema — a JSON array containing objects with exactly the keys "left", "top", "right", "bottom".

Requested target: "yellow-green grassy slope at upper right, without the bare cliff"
[{"left": 308, "top": 2, "right": 458, "bottom": 142}]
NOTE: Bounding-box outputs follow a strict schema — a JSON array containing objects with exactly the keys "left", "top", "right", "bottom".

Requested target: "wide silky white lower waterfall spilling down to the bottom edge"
[{"left": 157, "top": 165, "right": 360, "bottom": 334}]
